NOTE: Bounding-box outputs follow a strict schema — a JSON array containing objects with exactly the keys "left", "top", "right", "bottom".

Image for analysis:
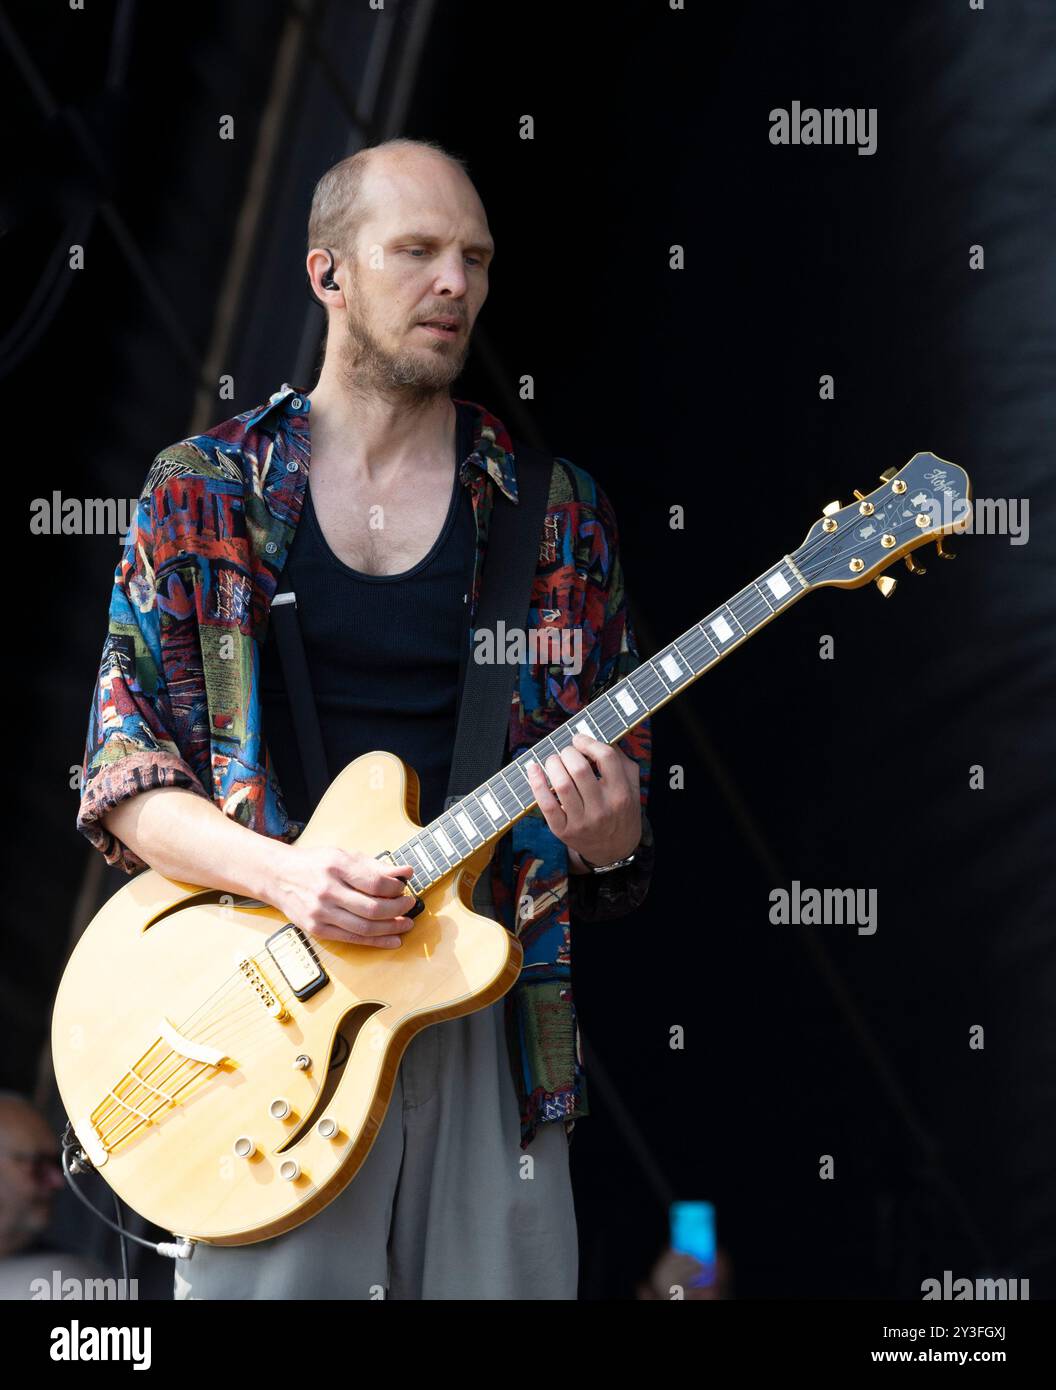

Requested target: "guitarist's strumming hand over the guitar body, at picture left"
[{"left": 268, "top": 844, "right": 414, "bottom": 948}]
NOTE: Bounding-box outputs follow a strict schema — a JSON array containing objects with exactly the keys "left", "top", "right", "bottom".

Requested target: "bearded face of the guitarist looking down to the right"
[{"left": 340, "top": 160, "right": 493, "bottom": 399}]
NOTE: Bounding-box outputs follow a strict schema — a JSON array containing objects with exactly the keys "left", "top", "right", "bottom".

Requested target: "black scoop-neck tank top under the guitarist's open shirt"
[{"left": 260, "top": 406, "right": 477, "bottom": 823}]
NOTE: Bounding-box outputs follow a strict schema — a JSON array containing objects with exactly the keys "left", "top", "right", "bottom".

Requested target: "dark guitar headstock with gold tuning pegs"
[{"left": 792, "top": 453, "right": 971, "bottom": 596}]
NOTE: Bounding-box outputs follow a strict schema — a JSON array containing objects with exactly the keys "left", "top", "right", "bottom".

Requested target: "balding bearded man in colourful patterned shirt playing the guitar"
[{"left": 79, "top": 140, "right": 652, "bottom": 1300}]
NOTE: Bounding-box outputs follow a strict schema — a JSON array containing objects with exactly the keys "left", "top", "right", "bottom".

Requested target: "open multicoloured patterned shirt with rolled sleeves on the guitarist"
[{"left": 78, "top": 384, "right": 653, "bottom": 1148}]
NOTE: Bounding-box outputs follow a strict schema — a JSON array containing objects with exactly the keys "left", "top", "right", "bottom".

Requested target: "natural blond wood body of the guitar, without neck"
[{"left": 51, "top": 752, "right": 522, "bottom": 1245}]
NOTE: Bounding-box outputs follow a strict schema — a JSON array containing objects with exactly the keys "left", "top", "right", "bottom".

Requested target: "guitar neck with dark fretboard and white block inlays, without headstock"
[{"left": 393, "top": 555, "right": 810, "bottom": 894}]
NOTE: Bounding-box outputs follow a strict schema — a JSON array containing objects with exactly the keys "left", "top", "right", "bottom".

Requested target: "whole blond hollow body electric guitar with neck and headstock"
[{"left": 51, "top": 453, "right": 971, "bottom": 1245}]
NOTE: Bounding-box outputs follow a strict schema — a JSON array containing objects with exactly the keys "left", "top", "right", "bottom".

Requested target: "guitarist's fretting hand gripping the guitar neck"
[{"left": 525, "top": 734, "right": 642, "bottom": 873}]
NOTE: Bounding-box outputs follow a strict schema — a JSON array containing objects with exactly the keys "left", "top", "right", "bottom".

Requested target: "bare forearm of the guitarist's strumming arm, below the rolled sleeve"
[{"left": 103, "top": 787, "right": 289, "bottom": 902}]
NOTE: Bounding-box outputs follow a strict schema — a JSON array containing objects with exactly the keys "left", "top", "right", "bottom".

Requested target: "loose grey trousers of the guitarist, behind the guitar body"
[{"left": 174, "top": 874, "right": 578, "bottom": 1300}]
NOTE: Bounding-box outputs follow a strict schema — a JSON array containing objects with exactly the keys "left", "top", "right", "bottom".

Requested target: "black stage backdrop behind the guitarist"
[{"left": 0, "top": 0, "right": 1056, "bottom": 1300}]
